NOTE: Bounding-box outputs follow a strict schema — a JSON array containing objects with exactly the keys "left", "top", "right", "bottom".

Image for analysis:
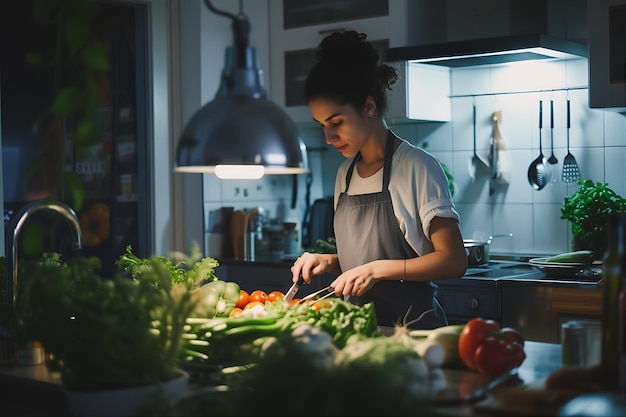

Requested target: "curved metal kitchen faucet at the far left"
[{"left": 6, "top": 199, "right": 82, "bottom": 307}]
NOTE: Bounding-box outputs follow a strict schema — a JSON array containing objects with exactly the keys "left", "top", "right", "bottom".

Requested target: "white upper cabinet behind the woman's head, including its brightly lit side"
[{"left": 269, "top": 0, "right": 450, "bottom": 123}]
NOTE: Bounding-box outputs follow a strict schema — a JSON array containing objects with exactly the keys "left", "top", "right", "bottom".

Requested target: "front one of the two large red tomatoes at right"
[{"left": 474, "top": 337, "right": 526, "bottom": 378}]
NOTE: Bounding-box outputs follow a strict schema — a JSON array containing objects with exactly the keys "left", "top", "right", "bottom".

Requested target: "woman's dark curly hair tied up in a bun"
[{"left": 304, "top": 31, "right": 398, "bottom": 116}]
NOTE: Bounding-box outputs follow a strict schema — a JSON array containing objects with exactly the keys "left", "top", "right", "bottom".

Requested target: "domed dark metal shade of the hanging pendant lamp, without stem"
[{"left": 175, "top": 96, "right": 308, "bottom": 174}]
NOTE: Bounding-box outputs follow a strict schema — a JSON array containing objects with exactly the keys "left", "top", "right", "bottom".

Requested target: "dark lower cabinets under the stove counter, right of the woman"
[{"left": 437, "top": 262, "right": 602, "bottom": 343}]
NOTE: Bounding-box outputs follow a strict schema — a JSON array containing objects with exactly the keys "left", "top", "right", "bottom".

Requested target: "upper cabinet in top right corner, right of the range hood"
[{"left": 588, "top": 0, "right": 626, "bottom": 113}]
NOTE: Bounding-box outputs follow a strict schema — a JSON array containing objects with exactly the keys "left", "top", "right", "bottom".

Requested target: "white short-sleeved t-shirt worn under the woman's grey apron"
[{"left": 335, "top": 140, "right": 459, "bottom": 256}]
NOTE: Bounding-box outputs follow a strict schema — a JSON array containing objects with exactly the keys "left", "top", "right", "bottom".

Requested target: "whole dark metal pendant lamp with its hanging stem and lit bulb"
[{"left": 174, "top": 0, "right": 308, "bottom": 179}]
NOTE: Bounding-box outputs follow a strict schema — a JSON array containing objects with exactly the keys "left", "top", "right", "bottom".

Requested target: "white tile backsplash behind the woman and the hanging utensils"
[{"left": 204, "top": 59, "right": 626, "bottom": 256}]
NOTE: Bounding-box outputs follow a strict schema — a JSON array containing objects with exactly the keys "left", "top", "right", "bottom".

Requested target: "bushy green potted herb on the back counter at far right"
[{"left": 561, "top": 180, "right": 626, "bottom": 256}]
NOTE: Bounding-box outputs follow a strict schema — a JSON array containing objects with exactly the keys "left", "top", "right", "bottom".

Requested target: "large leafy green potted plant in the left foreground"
[{"left": 2, "top": 247, "right": 223, "bottom": 415}]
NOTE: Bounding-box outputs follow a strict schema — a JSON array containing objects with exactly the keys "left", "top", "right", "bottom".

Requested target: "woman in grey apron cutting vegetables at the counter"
[{"left": 291, "top": 31, "right": 467, "bottom": 329}]
